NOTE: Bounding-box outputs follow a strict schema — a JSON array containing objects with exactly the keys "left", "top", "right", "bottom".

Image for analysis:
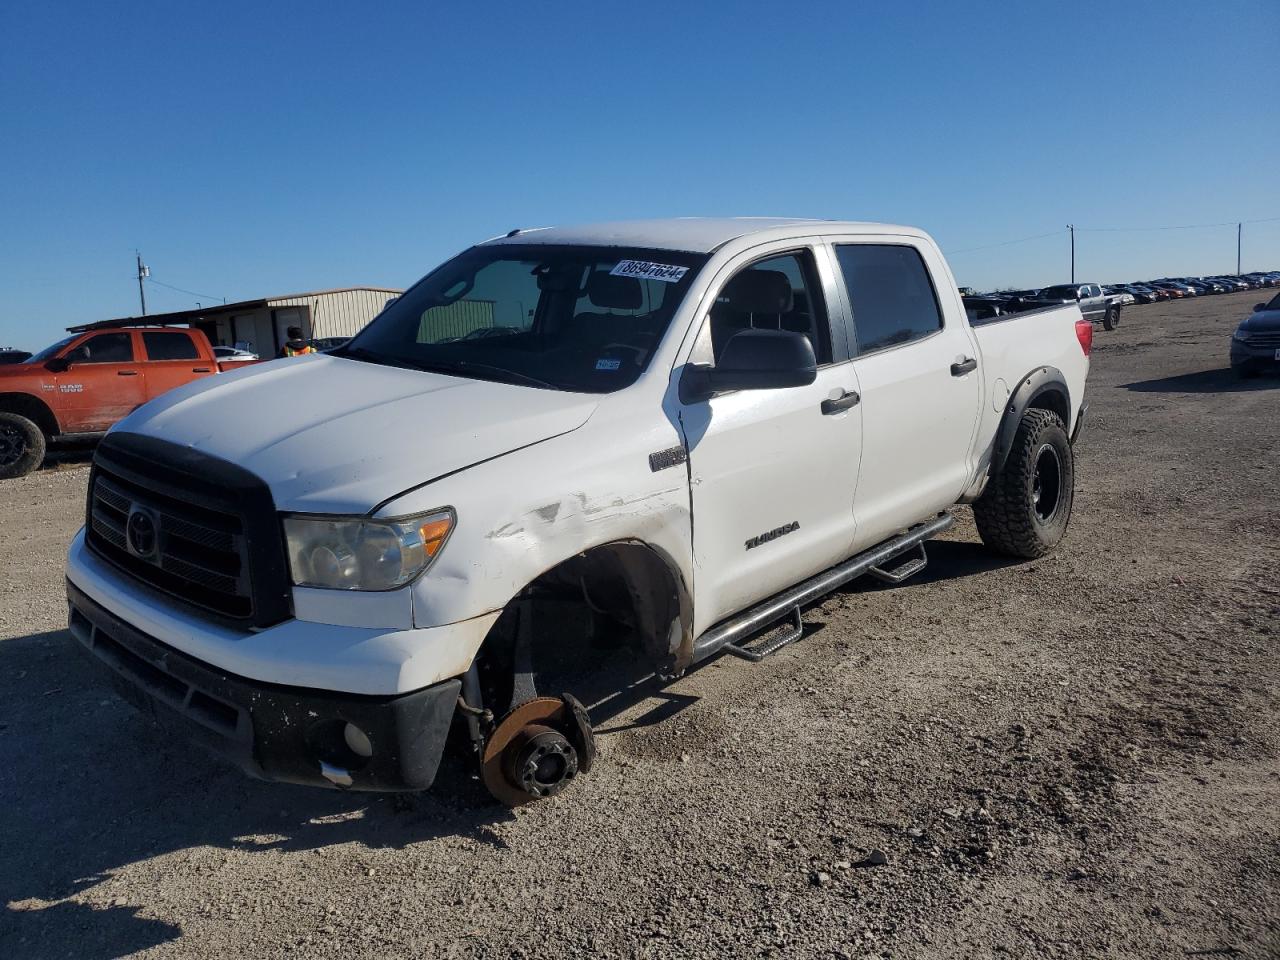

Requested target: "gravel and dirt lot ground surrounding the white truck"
[{"left": 0, "top": 293, "right": 1280, "bottom": 960}]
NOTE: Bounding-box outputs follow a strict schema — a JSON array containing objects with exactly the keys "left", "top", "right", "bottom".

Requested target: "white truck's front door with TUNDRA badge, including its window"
[{"left": 680, "top": 242, "right": 861, "bottom": 634}]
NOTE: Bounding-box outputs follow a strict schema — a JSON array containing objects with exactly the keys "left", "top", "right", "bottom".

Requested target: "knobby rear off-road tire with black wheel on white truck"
[{"left": 973, "top": 410, "right": 1075, "bottom": 559}]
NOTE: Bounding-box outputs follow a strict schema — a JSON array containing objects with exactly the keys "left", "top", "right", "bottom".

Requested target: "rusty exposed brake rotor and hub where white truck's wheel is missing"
[{"left": 480, "top": 694, "right": 595, "bottom": 806}]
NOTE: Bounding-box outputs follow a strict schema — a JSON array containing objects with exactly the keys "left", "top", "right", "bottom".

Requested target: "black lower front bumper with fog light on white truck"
[{"left": 67, "top": 581, "right": 461, "bottom": 791}]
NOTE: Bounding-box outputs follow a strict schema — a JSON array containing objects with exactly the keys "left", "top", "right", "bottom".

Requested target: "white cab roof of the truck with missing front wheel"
[{"left": 486, "top": 216, "right": 922, "bottom": 253}]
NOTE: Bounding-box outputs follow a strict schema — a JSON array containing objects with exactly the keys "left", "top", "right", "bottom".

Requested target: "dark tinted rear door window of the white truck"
[{"left": 836, "top": 243, "right": 942, "bottom": 355}]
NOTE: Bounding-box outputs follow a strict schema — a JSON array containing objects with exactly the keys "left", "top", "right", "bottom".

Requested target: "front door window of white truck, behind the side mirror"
[{"left": 710, "top": 251, "right": 831, "bottom": 366}]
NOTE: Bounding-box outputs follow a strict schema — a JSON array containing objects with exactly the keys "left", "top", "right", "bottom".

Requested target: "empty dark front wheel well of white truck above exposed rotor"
[{"left": 476, "top": 540, "right": 692, "bottom": 714}]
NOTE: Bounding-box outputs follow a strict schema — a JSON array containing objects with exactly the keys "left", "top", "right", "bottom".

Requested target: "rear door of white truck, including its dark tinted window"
[{"left": 832, "top": 238, "right": 983, "bottom": 549}]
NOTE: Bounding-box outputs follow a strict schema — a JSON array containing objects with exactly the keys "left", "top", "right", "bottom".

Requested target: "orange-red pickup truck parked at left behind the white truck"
[{"left": 0, "top": 325, "right": 243, "bottom": 479}]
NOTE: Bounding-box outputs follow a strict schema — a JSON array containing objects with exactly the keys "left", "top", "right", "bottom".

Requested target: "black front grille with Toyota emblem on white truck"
[{"left": 86, "top": 434, "right": 291, "bottom": 626}]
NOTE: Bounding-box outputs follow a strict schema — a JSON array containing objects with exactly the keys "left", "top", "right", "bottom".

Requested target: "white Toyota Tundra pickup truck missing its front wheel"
[{"left": 67, "top": 219, "right": 1092, "bottom": 805}]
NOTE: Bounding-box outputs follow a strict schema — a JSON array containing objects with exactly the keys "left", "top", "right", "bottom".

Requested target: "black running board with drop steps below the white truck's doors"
[{"left": 692, "top": 513, "right": 955, "bottom": 663}]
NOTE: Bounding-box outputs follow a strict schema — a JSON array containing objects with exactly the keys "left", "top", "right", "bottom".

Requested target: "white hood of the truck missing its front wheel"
[{"left": 115, "top": 355, "right": 598, "bottom": 513}]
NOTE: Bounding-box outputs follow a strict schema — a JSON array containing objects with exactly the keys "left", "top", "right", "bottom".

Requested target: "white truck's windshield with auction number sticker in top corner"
[{"left": 335, "top": 243, "right": 707, "bottom": 393}]
